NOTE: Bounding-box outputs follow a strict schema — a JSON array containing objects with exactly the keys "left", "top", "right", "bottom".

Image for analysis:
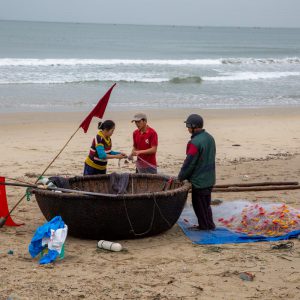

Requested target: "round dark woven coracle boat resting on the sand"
[{"left": 32, "top": 174, "right": 190, "bottom": 239}]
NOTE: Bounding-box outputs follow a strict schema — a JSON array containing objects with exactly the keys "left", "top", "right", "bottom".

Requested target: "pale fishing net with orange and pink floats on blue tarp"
[{"left": 213, "top": 201, "right": 300, "bottom": 236}]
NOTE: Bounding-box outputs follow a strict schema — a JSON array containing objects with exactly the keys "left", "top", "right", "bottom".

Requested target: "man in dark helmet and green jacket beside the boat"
[{"left": 178, "top": 114, "right": 216, "bottom": 230}]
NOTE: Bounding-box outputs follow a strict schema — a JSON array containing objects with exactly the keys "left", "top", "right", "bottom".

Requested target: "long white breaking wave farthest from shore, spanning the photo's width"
[{"left": 0, "top": 57, "right": 300, "bottom": 67}]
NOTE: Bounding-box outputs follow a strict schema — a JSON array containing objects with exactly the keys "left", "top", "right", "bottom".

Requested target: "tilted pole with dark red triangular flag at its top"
[{"left": 0, "top": 83, "right": 116, "bottom": 228}]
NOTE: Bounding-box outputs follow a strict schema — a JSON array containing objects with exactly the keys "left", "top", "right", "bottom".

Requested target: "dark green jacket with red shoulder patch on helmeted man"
[{"left": 178, "top": 129, "right": 216, "bottom": 188}]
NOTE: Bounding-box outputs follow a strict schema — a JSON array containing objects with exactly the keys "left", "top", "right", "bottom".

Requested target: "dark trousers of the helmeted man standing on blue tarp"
[{"left": 192, "top": 187, "right": 216, "bottom": 230}]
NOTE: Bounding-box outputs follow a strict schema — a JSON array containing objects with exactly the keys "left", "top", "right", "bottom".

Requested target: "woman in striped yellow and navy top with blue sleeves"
[{"left": 83, "top": 120, "right": 127, "bottom": 175}]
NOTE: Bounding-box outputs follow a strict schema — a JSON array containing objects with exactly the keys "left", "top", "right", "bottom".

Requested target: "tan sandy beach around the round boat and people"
[{"left": 0, "top": 107, "right": 300, "bottom": 299}]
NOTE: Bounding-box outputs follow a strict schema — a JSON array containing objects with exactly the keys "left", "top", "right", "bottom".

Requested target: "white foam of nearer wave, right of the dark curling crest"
[{"left": 203, "top": 72, "right": 300, "bottom": 81}]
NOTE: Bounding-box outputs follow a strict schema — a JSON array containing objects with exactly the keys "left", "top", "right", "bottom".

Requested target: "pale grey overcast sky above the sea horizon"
[{"left": 0, "top": 0, "right": 300, "bottom": 27}]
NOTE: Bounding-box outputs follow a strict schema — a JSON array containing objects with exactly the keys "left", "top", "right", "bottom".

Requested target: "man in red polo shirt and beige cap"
[{"left": 131, "top": 113, "right": 158, "bottom": 174}]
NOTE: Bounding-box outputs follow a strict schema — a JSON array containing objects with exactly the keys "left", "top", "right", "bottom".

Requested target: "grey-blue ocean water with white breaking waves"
[{"left": 0, "top": 21, "right": 300, "bottom": 112}]
